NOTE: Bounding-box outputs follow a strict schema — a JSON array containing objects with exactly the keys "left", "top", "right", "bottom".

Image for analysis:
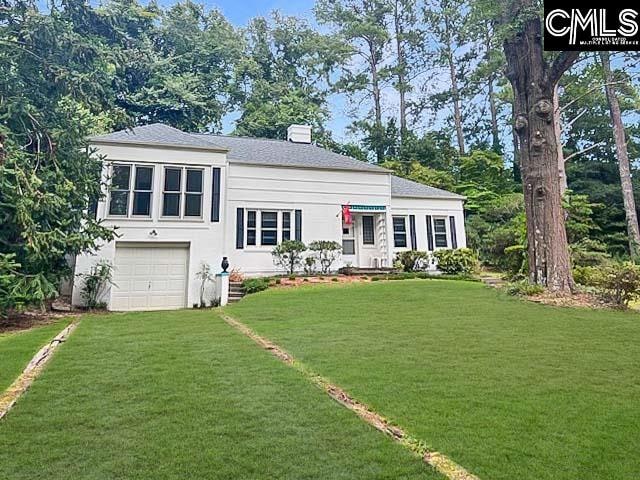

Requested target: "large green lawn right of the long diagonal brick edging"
[{"left": 226, "top": 280, "right": 640, "bottom": 480}]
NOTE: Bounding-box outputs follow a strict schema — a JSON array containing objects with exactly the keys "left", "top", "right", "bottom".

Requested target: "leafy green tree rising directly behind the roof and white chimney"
[{"left": 235, "top": 13, "right": 344, "bottom": 140}]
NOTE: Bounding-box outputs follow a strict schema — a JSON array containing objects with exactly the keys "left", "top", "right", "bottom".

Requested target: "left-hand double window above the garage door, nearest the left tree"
[{"left": 109, "top": 164, "right": 153, "bottom": 217}]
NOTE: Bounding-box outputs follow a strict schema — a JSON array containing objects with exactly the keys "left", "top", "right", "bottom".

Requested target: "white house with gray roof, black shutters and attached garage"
[{"left": 73, "top": 124, "right": 466, "bottom": 310}]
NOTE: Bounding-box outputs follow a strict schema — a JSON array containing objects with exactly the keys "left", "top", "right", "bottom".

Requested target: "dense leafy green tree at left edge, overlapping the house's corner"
[{"left": 0, "top": 0, "right": 113, "bottom": 311}]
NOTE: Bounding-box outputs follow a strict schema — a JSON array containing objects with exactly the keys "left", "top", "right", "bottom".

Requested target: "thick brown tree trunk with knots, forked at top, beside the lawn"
[{"left": 504, "top": 5, "right": 578, "bottom": 293}]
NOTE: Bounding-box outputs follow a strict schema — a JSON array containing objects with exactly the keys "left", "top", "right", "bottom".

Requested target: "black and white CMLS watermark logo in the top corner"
[{"left": 544, "top": 6, "right": 640, "bottom": 51}]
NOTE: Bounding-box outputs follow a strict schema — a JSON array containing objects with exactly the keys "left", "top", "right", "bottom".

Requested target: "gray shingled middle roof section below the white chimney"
[{"left": 193, "top": 134, "right": 388, "bottom": 172}]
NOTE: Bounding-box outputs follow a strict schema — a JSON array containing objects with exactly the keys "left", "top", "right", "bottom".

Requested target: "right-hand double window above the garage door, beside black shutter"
[{"left": 162, "top": 167, "right": 204, "bottom": 218}]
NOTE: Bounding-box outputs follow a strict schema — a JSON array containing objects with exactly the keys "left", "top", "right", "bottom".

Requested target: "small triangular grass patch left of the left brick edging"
[{"left": 0, "top": 320, "right": 69, "bottom": 392}]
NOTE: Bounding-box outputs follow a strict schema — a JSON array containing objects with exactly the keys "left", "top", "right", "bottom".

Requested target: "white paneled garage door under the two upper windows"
[{"left": 110, "top": 244, "right": 189, "bottom": 310}]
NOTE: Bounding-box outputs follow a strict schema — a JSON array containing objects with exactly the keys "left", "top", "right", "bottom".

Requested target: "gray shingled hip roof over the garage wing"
[{"left": 89, "top": 123, "right": 225, "bottom": 150}]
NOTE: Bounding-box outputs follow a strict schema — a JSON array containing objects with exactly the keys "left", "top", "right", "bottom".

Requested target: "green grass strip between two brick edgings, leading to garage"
[{"left": 0, "top": 311, "right": 440, "bottom": 480}]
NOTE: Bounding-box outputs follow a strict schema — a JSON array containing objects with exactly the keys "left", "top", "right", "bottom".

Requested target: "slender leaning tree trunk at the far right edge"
[{"left": 600, "top": 52, "right": 640, "bottom": 257}]
